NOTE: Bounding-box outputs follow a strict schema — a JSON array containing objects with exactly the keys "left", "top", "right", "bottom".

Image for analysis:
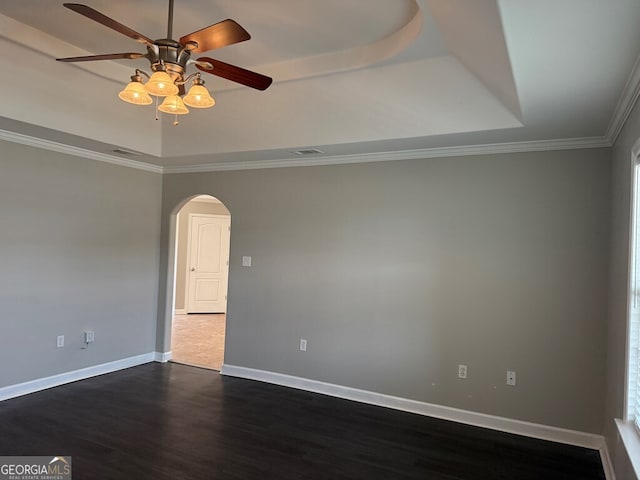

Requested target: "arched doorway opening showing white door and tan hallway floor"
[{"left": 171, "top": 195, "right": 231, "bottom": 371}]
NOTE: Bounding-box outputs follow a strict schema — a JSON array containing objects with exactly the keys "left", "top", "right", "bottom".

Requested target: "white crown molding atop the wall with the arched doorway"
[{"left": 162, "top": 137, "right": 611, "bottom": 174}]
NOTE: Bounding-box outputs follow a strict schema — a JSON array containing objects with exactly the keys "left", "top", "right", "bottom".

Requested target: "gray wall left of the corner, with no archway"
[{"left": 0, "top": 142, "right": 162, "bottom": 387}]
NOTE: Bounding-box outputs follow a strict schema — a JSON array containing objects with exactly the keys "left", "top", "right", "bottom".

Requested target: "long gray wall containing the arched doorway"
[{"left": 157, "top": 149, "right": 610, "bottom": 433}]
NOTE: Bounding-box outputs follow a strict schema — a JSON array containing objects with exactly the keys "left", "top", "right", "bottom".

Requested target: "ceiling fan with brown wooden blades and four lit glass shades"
[{"left": 56, "top": 0, "right": 273, "bottom": 124}]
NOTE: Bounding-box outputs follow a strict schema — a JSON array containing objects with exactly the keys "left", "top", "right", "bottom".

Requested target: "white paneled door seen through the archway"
[{"left": 187, "top": 213, "right": 231, "bottom": 313}]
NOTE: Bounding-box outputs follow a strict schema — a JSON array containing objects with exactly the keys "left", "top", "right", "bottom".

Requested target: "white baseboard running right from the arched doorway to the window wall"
[{"left": 220, "top": 364, "right": 615, "bottom": 480}]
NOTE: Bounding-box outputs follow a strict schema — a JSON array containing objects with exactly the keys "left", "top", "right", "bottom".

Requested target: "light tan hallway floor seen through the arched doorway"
[{"left": 171, "top": 313, "right": 226, "bottom": 370}]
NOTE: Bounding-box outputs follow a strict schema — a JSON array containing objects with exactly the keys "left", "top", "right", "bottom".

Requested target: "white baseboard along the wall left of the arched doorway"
[{"left": 0, "top": 352, "right": 156, "bottom": 401}]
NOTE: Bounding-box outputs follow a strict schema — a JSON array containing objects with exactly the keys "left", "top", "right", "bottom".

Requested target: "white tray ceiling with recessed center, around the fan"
[{"left": 0, "top": 0, "right": 640, "bottom": 171}]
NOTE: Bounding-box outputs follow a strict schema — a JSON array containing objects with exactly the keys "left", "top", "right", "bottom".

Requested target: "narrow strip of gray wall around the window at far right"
[{"left": 604, "top": 96, "right": 640, "bottom": 480}]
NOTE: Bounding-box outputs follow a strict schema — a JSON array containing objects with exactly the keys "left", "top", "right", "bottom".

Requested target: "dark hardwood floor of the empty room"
[{"left": 0, "top": 363, "right": 605, "bottom": 480}]
